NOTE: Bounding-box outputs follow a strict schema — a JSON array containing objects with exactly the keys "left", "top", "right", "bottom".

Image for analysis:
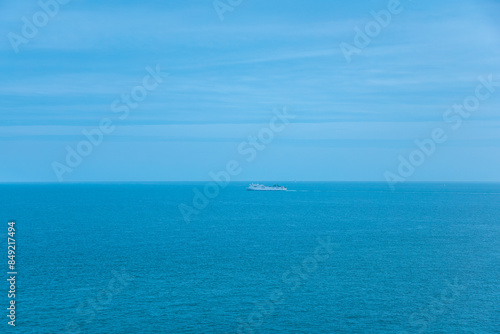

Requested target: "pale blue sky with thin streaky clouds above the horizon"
[{"left": 0, "top": 0, "right": 500, "bottom": 182}]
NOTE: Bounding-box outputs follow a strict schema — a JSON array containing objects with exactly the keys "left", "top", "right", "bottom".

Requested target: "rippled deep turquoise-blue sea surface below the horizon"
[{"left": 0, "top": 182, "right": 500, "bottom": 334}]
